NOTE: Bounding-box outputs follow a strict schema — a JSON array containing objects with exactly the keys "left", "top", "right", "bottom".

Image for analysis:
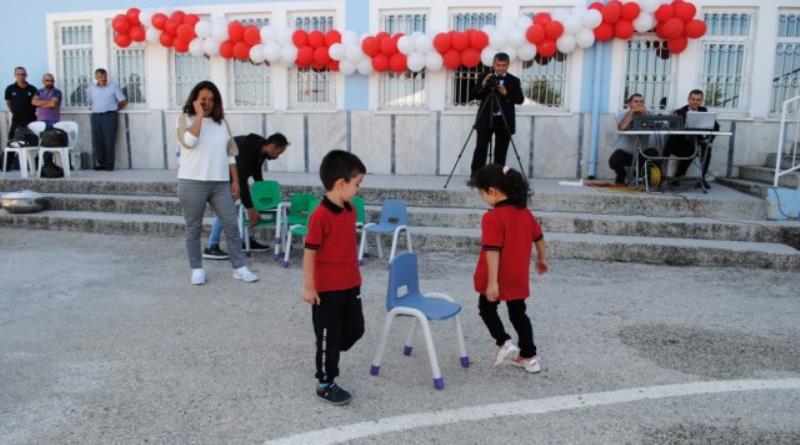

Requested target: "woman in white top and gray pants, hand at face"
[{"left": 178, "top": 81, "right": 258, "bottom": 284}]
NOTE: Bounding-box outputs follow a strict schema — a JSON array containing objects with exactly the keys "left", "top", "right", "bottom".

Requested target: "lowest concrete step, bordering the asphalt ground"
[{"left": 0, "top": 210, "right": 800, "bottom": 270}]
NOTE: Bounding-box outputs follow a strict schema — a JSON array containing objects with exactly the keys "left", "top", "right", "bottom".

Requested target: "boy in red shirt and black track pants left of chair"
[{"left": 303, "top": 150, "right": 367, "bottom": 405}]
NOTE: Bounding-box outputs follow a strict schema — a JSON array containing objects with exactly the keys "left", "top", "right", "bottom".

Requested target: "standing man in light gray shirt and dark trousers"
[{"left": 88, "top": 68, "right": 128, "bottom": 171}]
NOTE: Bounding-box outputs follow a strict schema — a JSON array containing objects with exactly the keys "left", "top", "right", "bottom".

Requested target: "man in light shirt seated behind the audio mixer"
[{"left": 608, "top": 93, "right": 658, "bottom": 184}]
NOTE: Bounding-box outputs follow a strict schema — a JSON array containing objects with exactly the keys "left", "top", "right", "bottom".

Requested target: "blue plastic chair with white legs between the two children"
[{"left": 370, "top": 252, "right": 469, "bottom": 389}]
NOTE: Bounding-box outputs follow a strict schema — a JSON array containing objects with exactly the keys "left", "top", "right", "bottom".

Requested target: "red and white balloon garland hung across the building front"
[{"left": 111, "top": 0, "right": 706, "bottom": 75}]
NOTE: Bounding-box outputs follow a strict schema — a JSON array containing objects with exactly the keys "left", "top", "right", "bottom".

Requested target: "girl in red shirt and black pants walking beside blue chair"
[{"left": 469, "top": 164, "right": 550, "bottom": 372}]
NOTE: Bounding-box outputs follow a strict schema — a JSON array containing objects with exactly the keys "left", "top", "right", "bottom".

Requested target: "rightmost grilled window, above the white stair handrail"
[{"left": 770, "top": 12, "right": 800, "bottom": 113}]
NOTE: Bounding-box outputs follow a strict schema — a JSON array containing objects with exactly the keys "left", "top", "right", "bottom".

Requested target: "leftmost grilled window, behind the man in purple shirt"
[{"left": 56, "top": 23, "right": 94, "bottom": 107}]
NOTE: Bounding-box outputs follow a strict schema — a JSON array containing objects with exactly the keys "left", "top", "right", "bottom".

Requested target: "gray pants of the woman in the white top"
[{"left": 178, "top": 179, "right": 245, "bottom": 269}]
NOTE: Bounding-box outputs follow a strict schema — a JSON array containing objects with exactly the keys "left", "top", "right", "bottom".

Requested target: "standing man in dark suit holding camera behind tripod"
[{"left": 472, "top": 53, "right": 525, "bottom": 175}]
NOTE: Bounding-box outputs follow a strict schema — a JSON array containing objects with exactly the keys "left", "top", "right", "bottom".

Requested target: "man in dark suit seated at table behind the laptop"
[{"left": 664, "top": 90, "right": 719, "bottom": 188}]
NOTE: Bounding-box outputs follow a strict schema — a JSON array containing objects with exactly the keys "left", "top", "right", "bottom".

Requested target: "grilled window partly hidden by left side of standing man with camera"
[{"left": 447, "top": 12, "right": 497, "bottom": 108}]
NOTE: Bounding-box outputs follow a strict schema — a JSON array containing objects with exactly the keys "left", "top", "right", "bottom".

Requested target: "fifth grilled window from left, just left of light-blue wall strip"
[{"left": 289, "top": 15, "right": 336, "bottom": 107}]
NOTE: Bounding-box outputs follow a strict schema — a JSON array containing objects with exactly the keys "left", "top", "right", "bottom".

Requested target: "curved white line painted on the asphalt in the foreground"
[{"left": 265, "top": 379, "right": 800, "bottom": 445}]
